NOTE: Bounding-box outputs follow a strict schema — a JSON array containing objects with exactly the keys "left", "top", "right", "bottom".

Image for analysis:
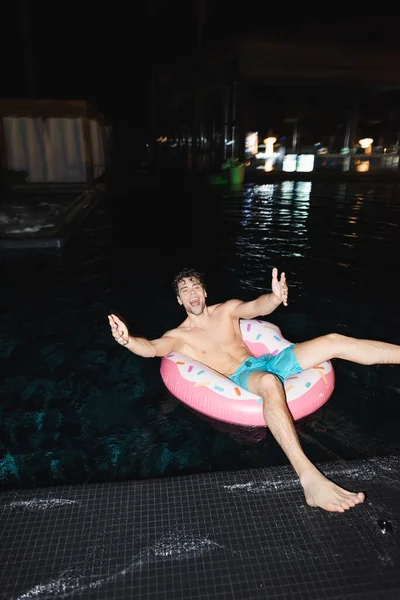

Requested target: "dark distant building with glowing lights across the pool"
[{"left": 152, "top": 35, "right": 400, "bottom": 171}]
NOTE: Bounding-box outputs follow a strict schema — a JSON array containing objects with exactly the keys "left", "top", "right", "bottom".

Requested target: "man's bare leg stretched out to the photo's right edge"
[{"left": 293, "top": 333, "right": 400, "bottom": 369}]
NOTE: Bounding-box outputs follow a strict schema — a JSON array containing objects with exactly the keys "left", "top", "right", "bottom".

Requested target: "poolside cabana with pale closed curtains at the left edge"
[{"left": 0, "top": 99, "right": 105, "bottom": 186}]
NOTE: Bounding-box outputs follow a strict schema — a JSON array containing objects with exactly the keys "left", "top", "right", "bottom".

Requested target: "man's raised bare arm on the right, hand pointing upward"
[{"left": 230, "top": 268, "right": 288, "bottom": 319}]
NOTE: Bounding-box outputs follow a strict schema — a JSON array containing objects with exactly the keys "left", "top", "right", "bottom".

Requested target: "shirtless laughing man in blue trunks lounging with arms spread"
[{"left": 108, "top": 268, "right": 400, "bottom": 512}]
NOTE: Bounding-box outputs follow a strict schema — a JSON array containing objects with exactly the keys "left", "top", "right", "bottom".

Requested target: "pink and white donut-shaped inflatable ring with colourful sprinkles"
[{"left": 161, "top": 319, "right": 335, "bottom": 427}]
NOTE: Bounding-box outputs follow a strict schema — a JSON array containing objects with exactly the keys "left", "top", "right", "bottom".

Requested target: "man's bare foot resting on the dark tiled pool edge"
[{"left": 301, "top": 469, "right": 365, "bottom": 512}]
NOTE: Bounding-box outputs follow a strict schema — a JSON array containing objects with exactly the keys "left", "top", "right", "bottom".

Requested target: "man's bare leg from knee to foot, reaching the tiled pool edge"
[{"left": 247, "top": 372, "right": 364, "bottom": 512}]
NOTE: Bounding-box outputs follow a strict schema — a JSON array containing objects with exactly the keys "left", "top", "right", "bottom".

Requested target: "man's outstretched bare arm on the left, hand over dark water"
[{"left": 108, "top": 314, "right": 179, "bottom": 358}]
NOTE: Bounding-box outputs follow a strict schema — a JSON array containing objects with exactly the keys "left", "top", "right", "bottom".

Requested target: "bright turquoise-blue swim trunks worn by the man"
[{"left": 229, "top": 344, "right": 303, "bottom": 391}]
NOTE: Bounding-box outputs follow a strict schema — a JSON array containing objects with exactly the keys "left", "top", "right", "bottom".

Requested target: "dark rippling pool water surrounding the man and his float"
[{"left": 0, "top": 181, "right": 400, "bottom": 488}]
